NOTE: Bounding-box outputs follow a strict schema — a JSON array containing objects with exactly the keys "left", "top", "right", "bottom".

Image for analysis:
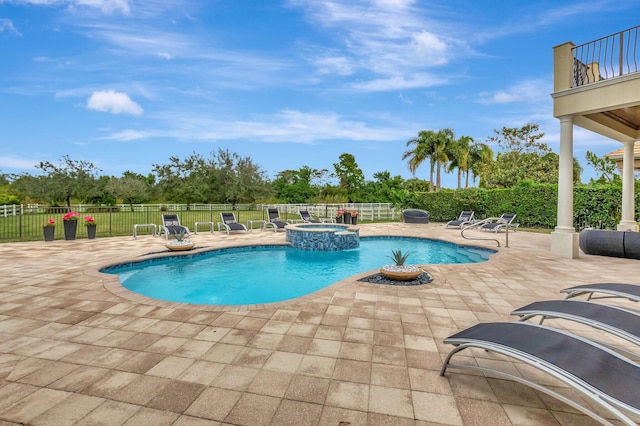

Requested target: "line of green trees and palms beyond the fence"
[{"left": 0, "top": 123, "right": 619, "bottom": 207}]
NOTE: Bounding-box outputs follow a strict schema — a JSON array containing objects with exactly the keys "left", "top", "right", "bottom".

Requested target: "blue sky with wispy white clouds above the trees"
[{"left": 0, "top": 0, "right": 640, "bottom": 187}]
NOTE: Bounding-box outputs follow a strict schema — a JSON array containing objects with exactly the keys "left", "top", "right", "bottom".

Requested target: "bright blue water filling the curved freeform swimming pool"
[{"left": 102, "top": 237, "right": 495, "bottom": 305}]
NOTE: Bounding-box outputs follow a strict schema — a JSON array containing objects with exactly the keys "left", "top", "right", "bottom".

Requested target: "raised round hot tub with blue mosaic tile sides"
[{"left": 284, "top": 223, "right": 360, "bottom": 251}]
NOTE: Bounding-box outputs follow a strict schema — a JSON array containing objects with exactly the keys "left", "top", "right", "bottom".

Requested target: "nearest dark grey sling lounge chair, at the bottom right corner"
[{"left": 440, "top": 322, "right": 640, "bottom": 425}]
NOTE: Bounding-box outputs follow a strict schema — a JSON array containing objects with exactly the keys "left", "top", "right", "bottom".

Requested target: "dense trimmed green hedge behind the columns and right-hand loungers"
[{"left": 412, "top": 181, "right": 640, "bottom": 229}]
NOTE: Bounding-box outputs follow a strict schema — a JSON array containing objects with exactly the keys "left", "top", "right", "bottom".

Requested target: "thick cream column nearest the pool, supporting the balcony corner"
[{"left": 551, "top": 116, "right": 578, "bottom": 259}]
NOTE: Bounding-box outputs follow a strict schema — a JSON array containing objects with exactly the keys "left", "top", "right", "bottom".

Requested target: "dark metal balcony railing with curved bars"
[{"left": 572, "top": 26, "right": 640, "bottom": 87}]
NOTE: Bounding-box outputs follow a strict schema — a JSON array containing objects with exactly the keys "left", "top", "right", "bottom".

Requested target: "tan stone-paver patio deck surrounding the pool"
[{"left": 0, "top": 223, "right": 640, "bottom": 426}]
